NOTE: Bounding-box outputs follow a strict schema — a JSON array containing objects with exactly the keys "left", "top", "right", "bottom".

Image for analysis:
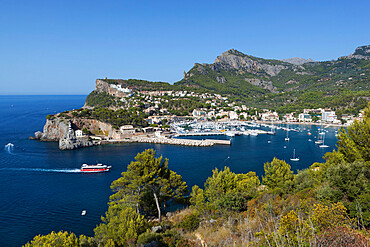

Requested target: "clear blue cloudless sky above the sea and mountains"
[{"left": 0, "top": 0, "right": 370, "bottom": 95}]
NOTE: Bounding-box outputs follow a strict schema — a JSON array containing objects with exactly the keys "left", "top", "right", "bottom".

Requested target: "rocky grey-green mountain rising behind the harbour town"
[{"left": 175, "top": 45, "right": 370, "bottom": 113}]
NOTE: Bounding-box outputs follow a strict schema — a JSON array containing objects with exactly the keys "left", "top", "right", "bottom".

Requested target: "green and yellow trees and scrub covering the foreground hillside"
[{"left": 25, "top": 104, "right": 370, "bottom": 246}]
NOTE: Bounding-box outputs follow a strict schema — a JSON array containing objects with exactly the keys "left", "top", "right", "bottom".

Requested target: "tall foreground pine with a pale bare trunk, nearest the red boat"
[{"left": 111, "top": 149, "right": 187, "bottom": 222}]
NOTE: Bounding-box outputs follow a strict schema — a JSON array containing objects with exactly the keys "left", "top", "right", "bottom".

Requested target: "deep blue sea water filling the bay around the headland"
[{"left": 0, "top": 95, "right": 337, "bottom": 246}]
